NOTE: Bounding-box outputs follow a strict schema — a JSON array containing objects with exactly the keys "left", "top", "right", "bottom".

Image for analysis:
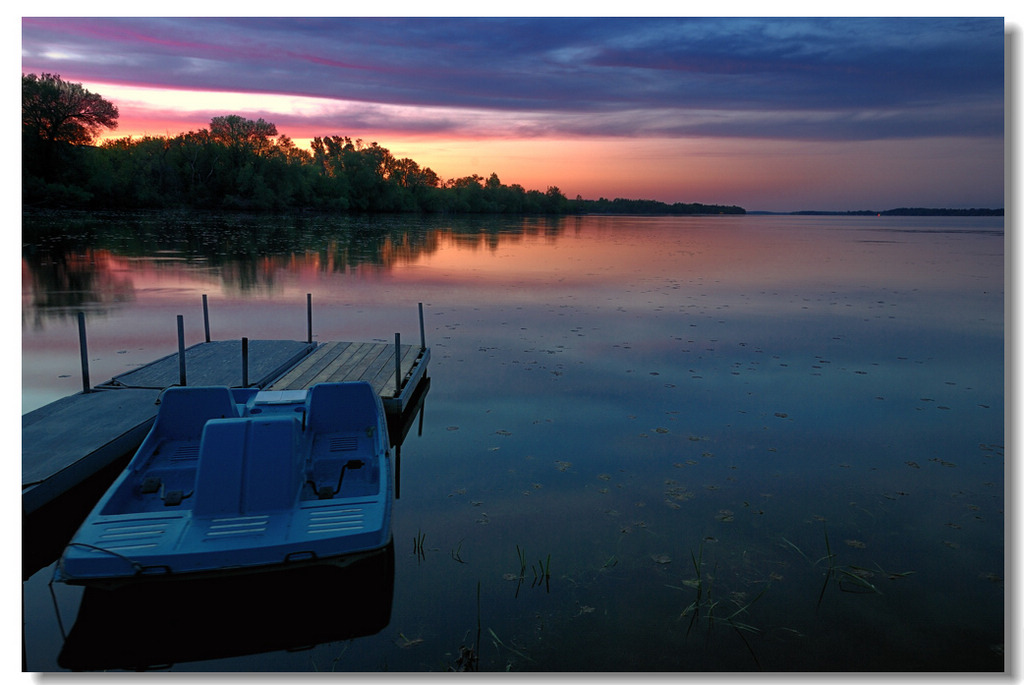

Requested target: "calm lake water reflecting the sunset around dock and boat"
[{"left": 22, "top": 214, "right": 1006, "bottom": 672}]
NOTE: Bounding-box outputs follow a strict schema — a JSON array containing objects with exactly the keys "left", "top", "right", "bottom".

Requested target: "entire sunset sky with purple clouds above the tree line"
[{"left": 22, "top": 16, "right": 1005, "bottom": 211}]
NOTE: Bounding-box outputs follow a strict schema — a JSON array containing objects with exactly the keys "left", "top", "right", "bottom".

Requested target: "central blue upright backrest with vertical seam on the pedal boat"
[{"left": 193, "top": 416, "right": 302, "bottom": 516}]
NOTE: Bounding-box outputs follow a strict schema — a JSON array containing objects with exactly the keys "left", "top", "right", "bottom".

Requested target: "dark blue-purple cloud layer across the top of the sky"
[{"left": 23, "top": 17, "right": 1004, "bottom": 139}]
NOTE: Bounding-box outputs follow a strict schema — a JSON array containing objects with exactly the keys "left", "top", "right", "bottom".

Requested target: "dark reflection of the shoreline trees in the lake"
[{"left": 22, "top": 212, "right": 573, "bottom": 316}]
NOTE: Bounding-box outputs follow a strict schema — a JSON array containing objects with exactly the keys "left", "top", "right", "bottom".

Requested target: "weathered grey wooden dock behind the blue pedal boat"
[{"left": 22, "top": 336, "right": 430, "bottom": 515}]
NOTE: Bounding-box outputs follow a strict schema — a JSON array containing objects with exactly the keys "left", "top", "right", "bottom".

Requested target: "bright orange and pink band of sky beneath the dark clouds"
[{"left": 84, "top": 76, "right": 1002, "bottom": 211}]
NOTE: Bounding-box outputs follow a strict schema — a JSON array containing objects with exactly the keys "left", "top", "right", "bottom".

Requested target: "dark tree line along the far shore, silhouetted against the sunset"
[{"left": 22, "top": 74, "right": 742, "bottom": 214}]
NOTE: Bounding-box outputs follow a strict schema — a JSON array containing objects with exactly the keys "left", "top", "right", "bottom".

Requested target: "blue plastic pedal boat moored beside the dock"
[{"left": 54, "top": 381, "right": 394, "bottom": 586}]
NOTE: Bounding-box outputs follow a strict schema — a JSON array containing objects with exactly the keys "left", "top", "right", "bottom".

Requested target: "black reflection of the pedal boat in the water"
[{"left": 57, "top": 542, "right": 394, "bottom": 671}]
